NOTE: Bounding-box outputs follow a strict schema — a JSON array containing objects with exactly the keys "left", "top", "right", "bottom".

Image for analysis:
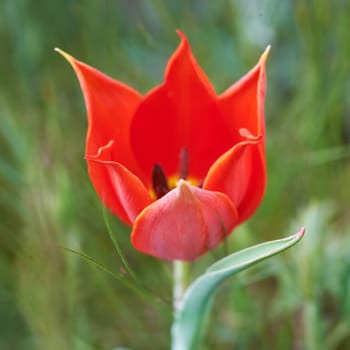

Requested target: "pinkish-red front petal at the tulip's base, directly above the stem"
[{"left": 131, "top": 180, "right": 237, "bottom": 261}]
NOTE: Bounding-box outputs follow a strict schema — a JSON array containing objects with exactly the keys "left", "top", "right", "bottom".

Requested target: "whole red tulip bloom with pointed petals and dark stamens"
[{"left": 60, "top": 32, "right": 268, "bottom": 261}]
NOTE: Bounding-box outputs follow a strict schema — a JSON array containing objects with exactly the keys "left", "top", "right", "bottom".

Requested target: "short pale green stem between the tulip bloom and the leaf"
[{"left": 173, "top": 260, "right": 189, "bottom": 314}]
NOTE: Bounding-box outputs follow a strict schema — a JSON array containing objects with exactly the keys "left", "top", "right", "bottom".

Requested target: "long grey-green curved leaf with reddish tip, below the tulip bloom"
[{"left": 172, "top": 228, "right": 305, "bottom": 350}]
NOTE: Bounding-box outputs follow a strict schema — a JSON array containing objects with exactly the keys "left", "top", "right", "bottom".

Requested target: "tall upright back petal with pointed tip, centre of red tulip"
[{"left": 131, "top": 33, "right": 232, "bottom": 179}]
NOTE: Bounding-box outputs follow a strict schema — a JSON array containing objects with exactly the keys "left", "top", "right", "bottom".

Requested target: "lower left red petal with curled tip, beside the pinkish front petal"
[{"left": 86, "top": 141, "right": 152, "bottom": 225}]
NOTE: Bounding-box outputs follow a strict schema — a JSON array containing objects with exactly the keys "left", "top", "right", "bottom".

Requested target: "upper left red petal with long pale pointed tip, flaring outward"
[{"left": 57, "top": 49, "right": 142, "bottom": 177}]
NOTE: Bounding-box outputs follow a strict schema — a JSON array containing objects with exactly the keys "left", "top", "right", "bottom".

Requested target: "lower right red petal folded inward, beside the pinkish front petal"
[{"left": 203, "top": 136, "right": 266, "bottom": 223}]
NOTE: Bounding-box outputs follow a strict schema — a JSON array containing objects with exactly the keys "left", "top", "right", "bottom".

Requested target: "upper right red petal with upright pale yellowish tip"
[{"left": 219, "top": 47, "right": 270, "bottom": 143}]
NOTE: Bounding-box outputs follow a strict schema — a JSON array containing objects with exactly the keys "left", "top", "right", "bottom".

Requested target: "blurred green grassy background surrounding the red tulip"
[{"left": 0, "top": 0, "right": 350, "bottom": 350}]
